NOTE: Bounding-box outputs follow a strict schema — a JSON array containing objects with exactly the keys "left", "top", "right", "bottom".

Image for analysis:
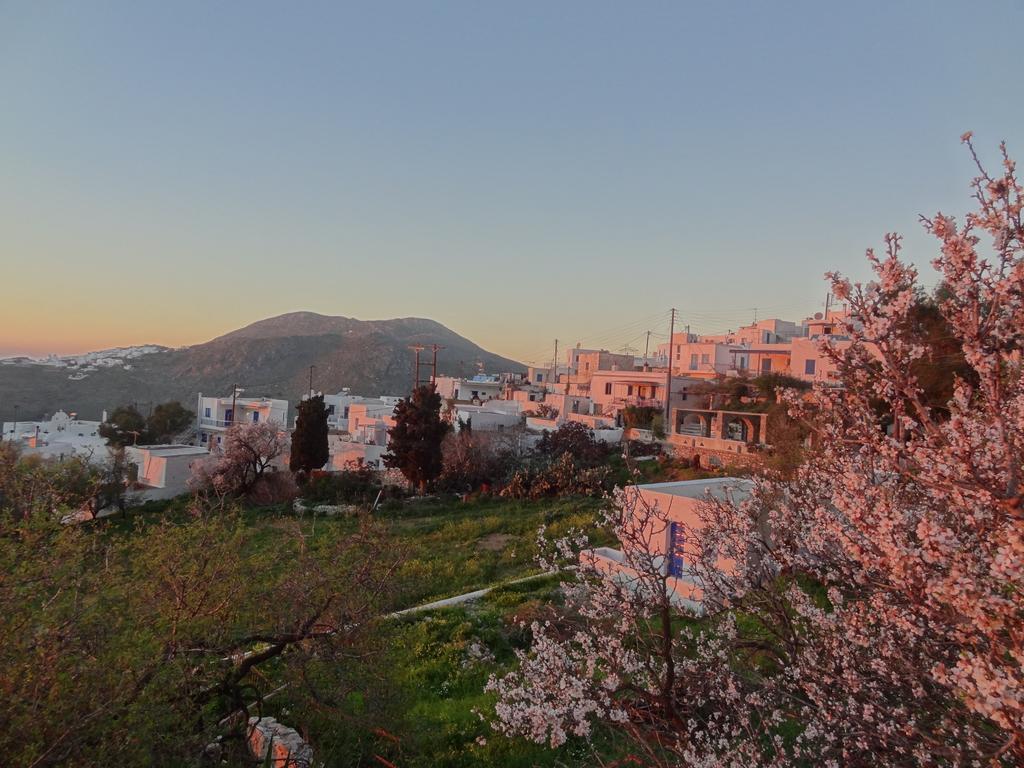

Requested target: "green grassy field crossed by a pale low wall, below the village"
[{"left": 275, "top": 499, "right": 612, "bottom": 767}]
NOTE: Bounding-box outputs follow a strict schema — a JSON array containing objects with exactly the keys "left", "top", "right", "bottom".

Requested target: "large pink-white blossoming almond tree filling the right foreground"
[{"left": 489, "top": 134, "right": 1024, "bottom": 766}]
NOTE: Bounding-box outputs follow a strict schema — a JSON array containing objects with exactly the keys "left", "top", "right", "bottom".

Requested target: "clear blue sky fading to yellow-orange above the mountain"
[{"left": 0, "top": 0, "right": 1024, "bottom": 362}]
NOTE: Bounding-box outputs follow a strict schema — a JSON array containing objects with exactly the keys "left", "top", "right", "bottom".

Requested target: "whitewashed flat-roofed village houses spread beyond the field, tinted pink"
[{"left": 3, "top": 309, "right": 848, "bottom": 503}]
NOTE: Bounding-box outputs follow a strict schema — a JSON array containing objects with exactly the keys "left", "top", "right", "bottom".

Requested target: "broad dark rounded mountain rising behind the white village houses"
[{"left": 0, "top": 312, "right": 524, "bottom": 421}]
